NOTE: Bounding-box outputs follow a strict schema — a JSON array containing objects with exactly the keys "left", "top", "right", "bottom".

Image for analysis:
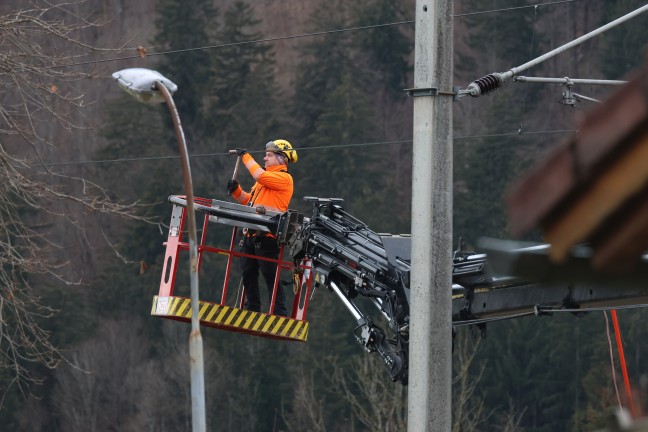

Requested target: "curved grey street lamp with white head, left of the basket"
[{"left": 112, "top": 68, "right": 207, "bottom": 432}]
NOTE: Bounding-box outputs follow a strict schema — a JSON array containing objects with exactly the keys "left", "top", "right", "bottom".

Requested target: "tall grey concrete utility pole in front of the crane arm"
[{"left": 407, "top": 0, "right": 453, "bottom": 432}]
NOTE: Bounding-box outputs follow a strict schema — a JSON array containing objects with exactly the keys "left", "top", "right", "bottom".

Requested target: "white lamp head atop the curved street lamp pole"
[{"left": 112, "top": 68, "right": 178, "bottom": 103}]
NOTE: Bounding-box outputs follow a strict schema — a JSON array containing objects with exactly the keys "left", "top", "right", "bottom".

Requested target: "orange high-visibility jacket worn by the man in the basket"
[{"left": 232, "top": 153, "right": 293, "bottom": 212}]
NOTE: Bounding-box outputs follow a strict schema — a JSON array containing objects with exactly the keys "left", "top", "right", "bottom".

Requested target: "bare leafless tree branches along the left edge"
[{"left": 0, "top": 0, "right": 158, "bottom": 406}]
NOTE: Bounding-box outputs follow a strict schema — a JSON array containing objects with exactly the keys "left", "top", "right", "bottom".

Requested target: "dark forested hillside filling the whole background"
[{"left": 0, "top": 0, "right": 648, "bottom": 432}]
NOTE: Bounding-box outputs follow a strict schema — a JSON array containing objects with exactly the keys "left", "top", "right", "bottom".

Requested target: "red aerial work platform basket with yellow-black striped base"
[{"left": 151, "top": 196, "right": 312, "bottom": 341}]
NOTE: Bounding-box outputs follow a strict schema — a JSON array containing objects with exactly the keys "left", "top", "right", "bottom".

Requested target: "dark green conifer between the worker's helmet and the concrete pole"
[{"left": 294, "top": 1, "right": 409, "bottom": 231}]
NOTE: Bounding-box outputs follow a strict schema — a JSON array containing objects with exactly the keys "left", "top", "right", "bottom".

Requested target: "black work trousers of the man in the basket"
[{"left": 241, "top": 236, "right": 288, "bottom": 316}]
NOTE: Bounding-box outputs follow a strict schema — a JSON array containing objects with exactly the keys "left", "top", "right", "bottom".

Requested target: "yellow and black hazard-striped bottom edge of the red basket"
[{"left": 151, "top": 296, "right": 308, "bottom": 342}]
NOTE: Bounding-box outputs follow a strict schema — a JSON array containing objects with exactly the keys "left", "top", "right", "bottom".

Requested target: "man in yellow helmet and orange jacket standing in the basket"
[{"left": 227, "top": 139, "right": 297, "bottom": 316}]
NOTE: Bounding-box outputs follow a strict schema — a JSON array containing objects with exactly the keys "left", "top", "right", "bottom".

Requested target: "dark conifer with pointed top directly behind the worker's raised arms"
[{"left": 197, "top": 1, "right": 292, "bottom": 199}]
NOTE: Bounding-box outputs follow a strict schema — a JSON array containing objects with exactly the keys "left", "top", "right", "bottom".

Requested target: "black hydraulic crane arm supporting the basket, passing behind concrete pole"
[{"left": 178, "top": 197, "right": 648, "bottom": 384}]
